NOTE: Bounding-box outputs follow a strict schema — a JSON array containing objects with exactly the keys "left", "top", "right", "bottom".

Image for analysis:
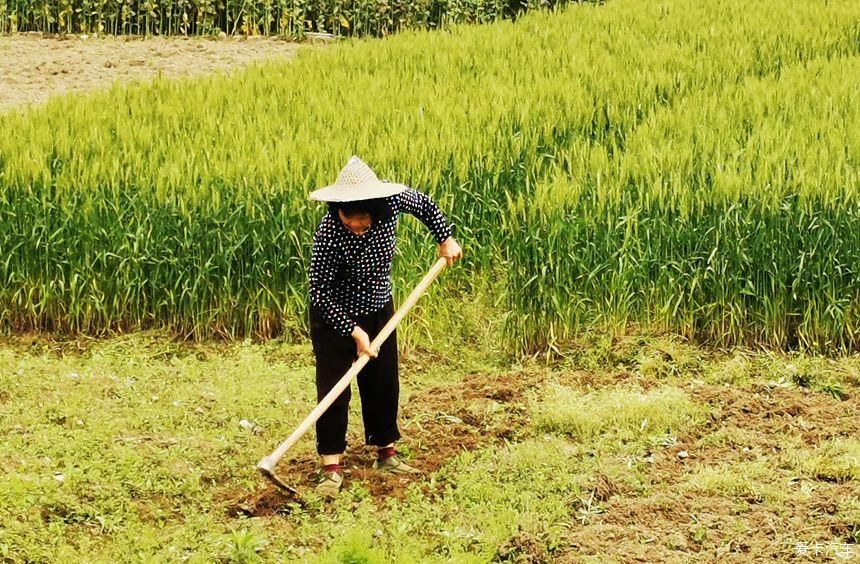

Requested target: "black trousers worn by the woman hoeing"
[{"left": 310, "top": 301, "right": 400, "bottom": 455}]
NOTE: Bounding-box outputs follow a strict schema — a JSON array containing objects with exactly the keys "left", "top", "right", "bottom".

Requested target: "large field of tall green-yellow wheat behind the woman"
[{"left": 0, "top": 0, "right": 860, "bottom": 351}]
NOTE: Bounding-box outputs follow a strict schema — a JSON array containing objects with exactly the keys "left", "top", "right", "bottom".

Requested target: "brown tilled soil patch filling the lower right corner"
[{"left": 554, "top": 385, "right": 860, "bottom": 563}]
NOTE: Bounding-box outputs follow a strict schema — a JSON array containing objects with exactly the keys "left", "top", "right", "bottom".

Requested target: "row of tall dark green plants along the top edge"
[{"left": 0, "top": 0, "right": 567, "bottom": 38}]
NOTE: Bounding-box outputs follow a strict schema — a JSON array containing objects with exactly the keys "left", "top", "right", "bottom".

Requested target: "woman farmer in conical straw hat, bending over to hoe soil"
[{"left": 310, "top": 156, "right": 463, "bottom": 496}]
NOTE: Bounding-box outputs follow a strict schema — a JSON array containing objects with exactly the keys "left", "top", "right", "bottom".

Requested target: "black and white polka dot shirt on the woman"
[{"left": 310, "top": 188, "right": 452, "bottom": 335}]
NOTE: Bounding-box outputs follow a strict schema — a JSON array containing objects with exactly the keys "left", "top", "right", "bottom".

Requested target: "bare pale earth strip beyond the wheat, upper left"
[{"left": 0, "top": 34, "right": 299, "bottom": 112}]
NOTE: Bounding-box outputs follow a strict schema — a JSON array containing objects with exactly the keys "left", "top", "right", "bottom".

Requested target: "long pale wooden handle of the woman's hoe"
[{"left": 257, "top": 257, "right": 447, "bottom": 475}]
